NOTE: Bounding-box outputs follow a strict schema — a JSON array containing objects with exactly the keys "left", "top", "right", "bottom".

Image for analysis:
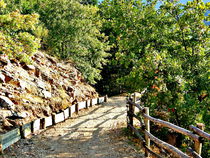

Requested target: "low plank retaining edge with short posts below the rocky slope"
[{"left": 0, "top": 96, "right": 108, "bottom": 154}]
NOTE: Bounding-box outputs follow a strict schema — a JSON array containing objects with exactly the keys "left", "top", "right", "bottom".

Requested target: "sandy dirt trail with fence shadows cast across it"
[{"left": 2, "top": 97, "right": 144, "bottom": 158}]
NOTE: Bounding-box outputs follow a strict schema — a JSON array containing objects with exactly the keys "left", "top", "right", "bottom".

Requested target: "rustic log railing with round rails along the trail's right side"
[{"left": 127, "top": 93, "right": 210, "bottom": 158}]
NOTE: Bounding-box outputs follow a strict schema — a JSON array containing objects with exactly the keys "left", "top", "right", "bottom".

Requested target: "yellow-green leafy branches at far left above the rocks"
[{"left": 0, "top": 0, "right": 46, "bottom": 62}]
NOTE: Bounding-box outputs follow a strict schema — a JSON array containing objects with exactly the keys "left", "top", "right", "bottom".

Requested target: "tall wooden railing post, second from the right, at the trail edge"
[{"left": 144, "top": 107, "right": 150, "bottom": 157}]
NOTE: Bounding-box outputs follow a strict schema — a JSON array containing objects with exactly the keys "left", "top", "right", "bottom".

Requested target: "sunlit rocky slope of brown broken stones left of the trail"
[{"left": 0, "top": 52, "right": 98, "bottom": 133}]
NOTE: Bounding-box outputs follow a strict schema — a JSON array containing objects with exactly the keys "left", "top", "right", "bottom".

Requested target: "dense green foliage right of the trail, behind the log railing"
[{"left": 99, "top": 0, "right": 210, "bottom": 156}]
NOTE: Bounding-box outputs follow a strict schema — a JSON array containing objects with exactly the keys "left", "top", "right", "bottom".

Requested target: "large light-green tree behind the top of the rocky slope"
[{"left": 5, "top": 0, "right": 108, "bottom": 84}]
